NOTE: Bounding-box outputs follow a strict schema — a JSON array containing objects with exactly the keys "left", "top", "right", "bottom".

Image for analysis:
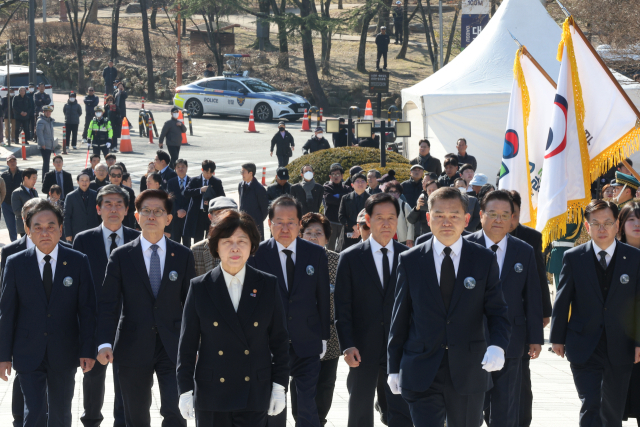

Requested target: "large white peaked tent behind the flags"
[{"left": 402, "top": 0, "right": 640, "bottom": 176}]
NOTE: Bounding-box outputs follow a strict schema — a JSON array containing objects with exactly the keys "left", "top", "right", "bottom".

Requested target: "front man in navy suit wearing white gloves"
[{"left": 387, "top": 187, "right": 511, "bottom": 427}]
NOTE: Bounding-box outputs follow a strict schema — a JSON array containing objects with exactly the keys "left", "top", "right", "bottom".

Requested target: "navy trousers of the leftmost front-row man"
[{"left": 19, "top": 354, "right": 76, "bottom": 427}]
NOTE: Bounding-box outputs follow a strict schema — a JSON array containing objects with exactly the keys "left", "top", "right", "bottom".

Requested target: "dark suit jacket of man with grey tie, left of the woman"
[{"left": 96, "top": 237, "right": 195, "bottom": 366}]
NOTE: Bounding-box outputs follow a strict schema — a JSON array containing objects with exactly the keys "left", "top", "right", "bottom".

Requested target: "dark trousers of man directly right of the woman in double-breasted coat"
[{"left": 264, "top": 346, "right": 320, "bottom": 427}]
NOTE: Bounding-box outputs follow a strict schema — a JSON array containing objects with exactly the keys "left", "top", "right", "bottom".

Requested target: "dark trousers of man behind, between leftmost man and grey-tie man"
[{"left": 80, "top": 361, "right": 126, "bottom": 427}]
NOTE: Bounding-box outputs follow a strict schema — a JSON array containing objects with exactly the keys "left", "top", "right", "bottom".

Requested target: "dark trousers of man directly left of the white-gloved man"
[{"left": 347, "top": 353, "right": 413, "bottom": 427}]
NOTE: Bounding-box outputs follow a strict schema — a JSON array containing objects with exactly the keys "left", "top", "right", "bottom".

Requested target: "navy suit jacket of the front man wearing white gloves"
[{"left": 388, "top": 239, "right": 511, "bottom": 394}]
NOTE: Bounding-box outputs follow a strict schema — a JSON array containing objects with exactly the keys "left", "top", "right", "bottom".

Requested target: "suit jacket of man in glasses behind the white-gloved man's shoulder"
[{"left": 465, "top": 230, "right": 544, "bottom": 358}]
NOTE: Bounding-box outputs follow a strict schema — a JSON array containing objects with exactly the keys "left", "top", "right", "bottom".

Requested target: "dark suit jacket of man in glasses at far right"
[{"left": 549, "top": 241, "right": 640, "bottom": 366}]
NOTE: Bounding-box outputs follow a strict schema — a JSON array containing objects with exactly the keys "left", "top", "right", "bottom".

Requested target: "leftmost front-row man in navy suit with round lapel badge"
[{"left": 0, "top": 201, "right": 95, "bottom": 427}]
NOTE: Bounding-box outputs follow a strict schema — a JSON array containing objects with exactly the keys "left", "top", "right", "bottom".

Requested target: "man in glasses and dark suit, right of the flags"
[{"left": 549, "top": 200, "right": 640, "bottom": 427}]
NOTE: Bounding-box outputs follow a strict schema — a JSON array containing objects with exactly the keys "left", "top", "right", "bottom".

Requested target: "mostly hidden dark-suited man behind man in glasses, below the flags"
[{"left": 508, "top": 191, "right": 551, "bottom": 427}]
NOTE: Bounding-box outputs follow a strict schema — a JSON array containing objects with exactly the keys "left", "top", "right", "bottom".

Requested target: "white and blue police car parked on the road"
[{"left": 173, "top": 76, "right": 310, "bottom": 122}]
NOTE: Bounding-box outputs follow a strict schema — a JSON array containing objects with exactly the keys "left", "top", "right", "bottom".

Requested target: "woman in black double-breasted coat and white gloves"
[{"left": 177, "top": 210, "right": 289, "bottom": 427}]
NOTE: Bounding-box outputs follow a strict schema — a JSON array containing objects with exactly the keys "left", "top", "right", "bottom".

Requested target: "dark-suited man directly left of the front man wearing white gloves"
[{"left": 334, "top": 193, "right": 413, "bottom": 427}]
